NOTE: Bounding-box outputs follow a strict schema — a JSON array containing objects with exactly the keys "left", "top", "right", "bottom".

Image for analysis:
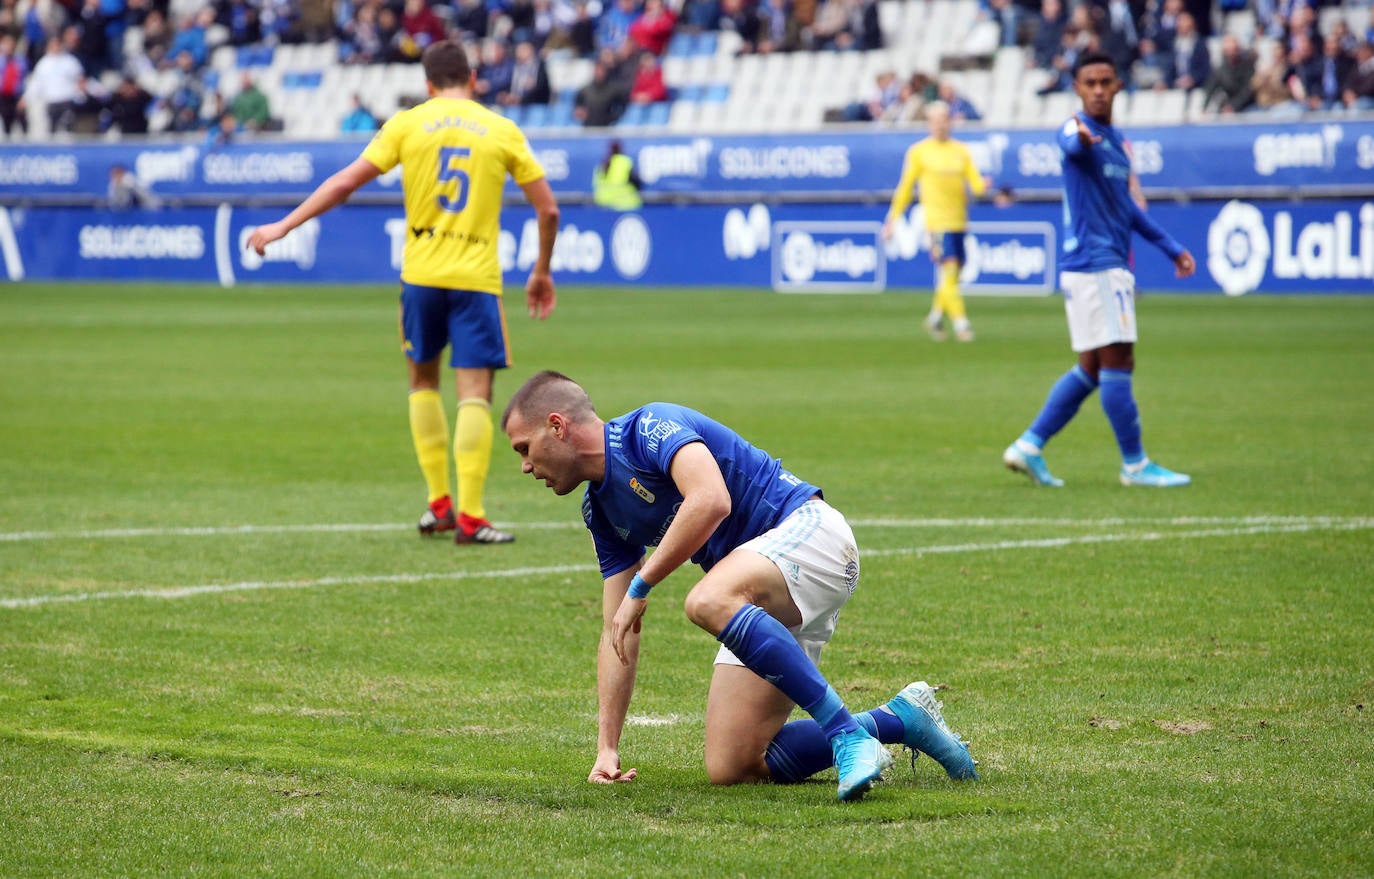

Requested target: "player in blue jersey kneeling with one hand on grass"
[{"left": 502, "top": 371, "right": 977, "bottom": 801}]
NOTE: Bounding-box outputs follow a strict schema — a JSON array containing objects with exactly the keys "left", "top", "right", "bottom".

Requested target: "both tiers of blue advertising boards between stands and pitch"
[{"left": 0, "top": 121, "right": 1374, "bottom": 294}]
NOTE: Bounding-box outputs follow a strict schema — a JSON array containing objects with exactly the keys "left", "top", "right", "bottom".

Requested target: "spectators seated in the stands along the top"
[{"left": 0, "top": 0, "right": 1374, "bottom": 138}]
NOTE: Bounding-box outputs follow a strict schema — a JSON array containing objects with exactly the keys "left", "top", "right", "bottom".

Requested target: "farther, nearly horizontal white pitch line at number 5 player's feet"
[{"left": 0, "top": 516, "right": 1352, "bottom": 543}]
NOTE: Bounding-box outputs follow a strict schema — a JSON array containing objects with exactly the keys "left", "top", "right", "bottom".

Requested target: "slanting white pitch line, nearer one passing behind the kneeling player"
[{"left": 0, "top": 518, "right": 1374, "bottom": 608}]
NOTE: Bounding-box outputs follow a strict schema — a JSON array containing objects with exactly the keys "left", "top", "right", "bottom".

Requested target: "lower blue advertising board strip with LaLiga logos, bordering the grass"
[{"left": 0, "top": 199, "right": 1374, "bottom": 295}]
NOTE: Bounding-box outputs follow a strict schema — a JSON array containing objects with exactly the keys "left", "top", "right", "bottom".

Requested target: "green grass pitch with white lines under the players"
[{"left": 0, "top": 284, "right": 1374, "bottom": 878}]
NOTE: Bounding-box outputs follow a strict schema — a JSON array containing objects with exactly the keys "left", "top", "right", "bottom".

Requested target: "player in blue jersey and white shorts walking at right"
[{"left": 1002, "top": 52, "right": 1197, "bottom": 488}]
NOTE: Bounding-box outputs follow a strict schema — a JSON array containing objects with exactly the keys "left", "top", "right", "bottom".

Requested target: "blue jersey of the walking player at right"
[{"left": 1058, "top": 114, "right": 1183, "bottom": 272}]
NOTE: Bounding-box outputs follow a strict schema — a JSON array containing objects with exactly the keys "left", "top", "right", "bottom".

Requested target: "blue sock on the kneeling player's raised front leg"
[{"left": 716, "top": 604, "right": 859, "bottom": 739}]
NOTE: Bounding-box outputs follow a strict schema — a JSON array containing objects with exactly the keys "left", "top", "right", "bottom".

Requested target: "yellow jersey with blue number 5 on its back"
[{"left": 363, "top": 98, "right": 544, "bottom": 295}]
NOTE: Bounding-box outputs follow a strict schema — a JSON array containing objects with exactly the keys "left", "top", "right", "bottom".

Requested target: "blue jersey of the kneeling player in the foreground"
[{"left": 583, "top": 402, "right": 820, "bottom": 578}]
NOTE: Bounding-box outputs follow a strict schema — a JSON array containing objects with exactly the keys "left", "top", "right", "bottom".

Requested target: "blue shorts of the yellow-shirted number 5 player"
[{"left": 401, "top": 283, "right": 511, "bottom": 369}]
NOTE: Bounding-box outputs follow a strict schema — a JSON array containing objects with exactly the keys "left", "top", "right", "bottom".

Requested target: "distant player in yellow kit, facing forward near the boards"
[{"left": 882, "top": 100, "right": 992, "bottom": 342}]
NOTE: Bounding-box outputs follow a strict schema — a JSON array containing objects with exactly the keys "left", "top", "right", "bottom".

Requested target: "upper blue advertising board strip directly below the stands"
[{"left": 0, "top": 122, "right": 1374, "bottom": 205}]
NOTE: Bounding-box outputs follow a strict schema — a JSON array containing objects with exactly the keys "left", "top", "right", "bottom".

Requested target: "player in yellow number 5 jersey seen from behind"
[{"left": 249, "top": 40, "right": 558, "bottom": 544}]
